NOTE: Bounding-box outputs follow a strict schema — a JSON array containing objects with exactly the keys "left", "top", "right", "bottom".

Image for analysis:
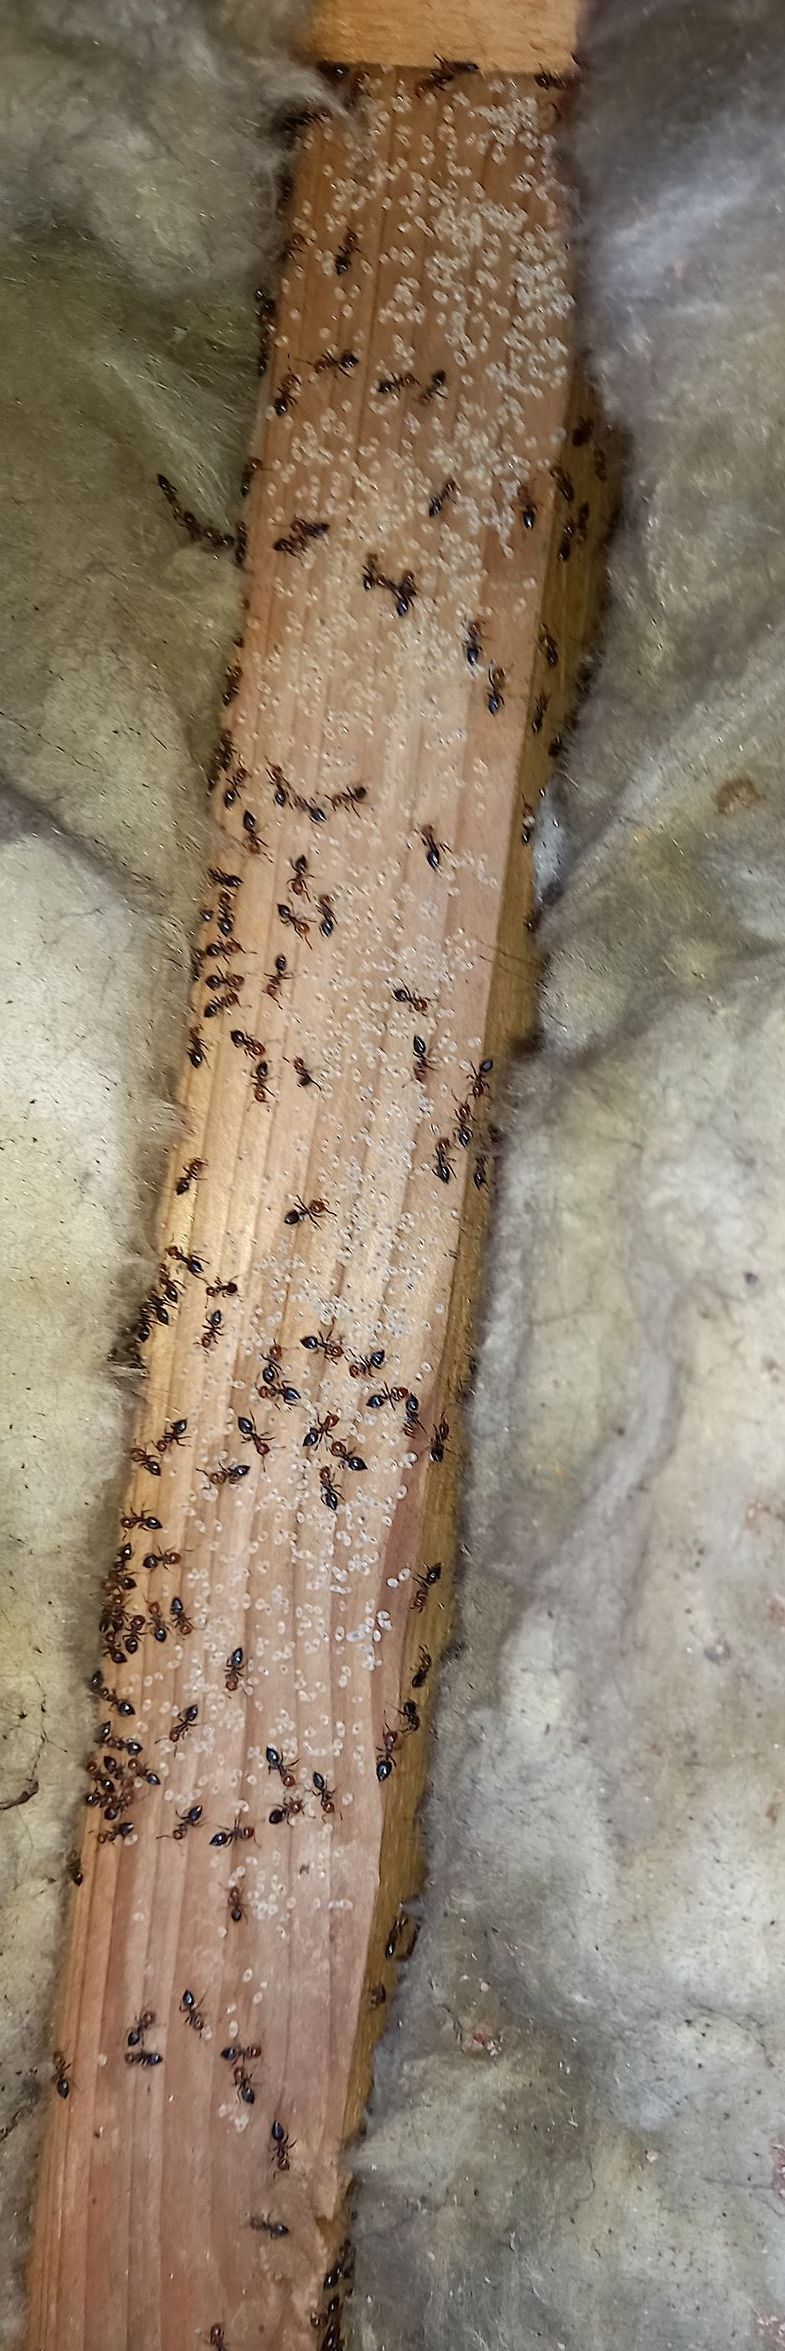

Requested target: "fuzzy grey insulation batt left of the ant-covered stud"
[{"left": 0, "top": 0, "right": 313, "bottom": 2342}]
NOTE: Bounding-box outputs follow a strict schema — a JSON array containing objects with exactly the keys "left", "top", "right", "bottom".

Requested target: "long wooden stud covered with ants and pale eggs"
[{"left": 28, "top": 75, "right": 609, "bottom": 2351}]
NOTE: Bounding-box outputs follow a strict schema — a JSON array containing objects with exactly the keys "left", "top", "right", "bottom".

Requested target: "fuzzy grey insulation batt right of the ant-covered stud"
[{"left": 353, "top": 0, "right": 785, "bottom": 2351}]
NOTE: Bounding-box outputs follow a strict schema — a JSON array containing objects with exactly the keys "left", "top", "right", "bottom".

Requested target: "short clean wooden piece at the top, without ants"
[{"left": 310, "top": 0, "right": 578, "bottom": 75}]
